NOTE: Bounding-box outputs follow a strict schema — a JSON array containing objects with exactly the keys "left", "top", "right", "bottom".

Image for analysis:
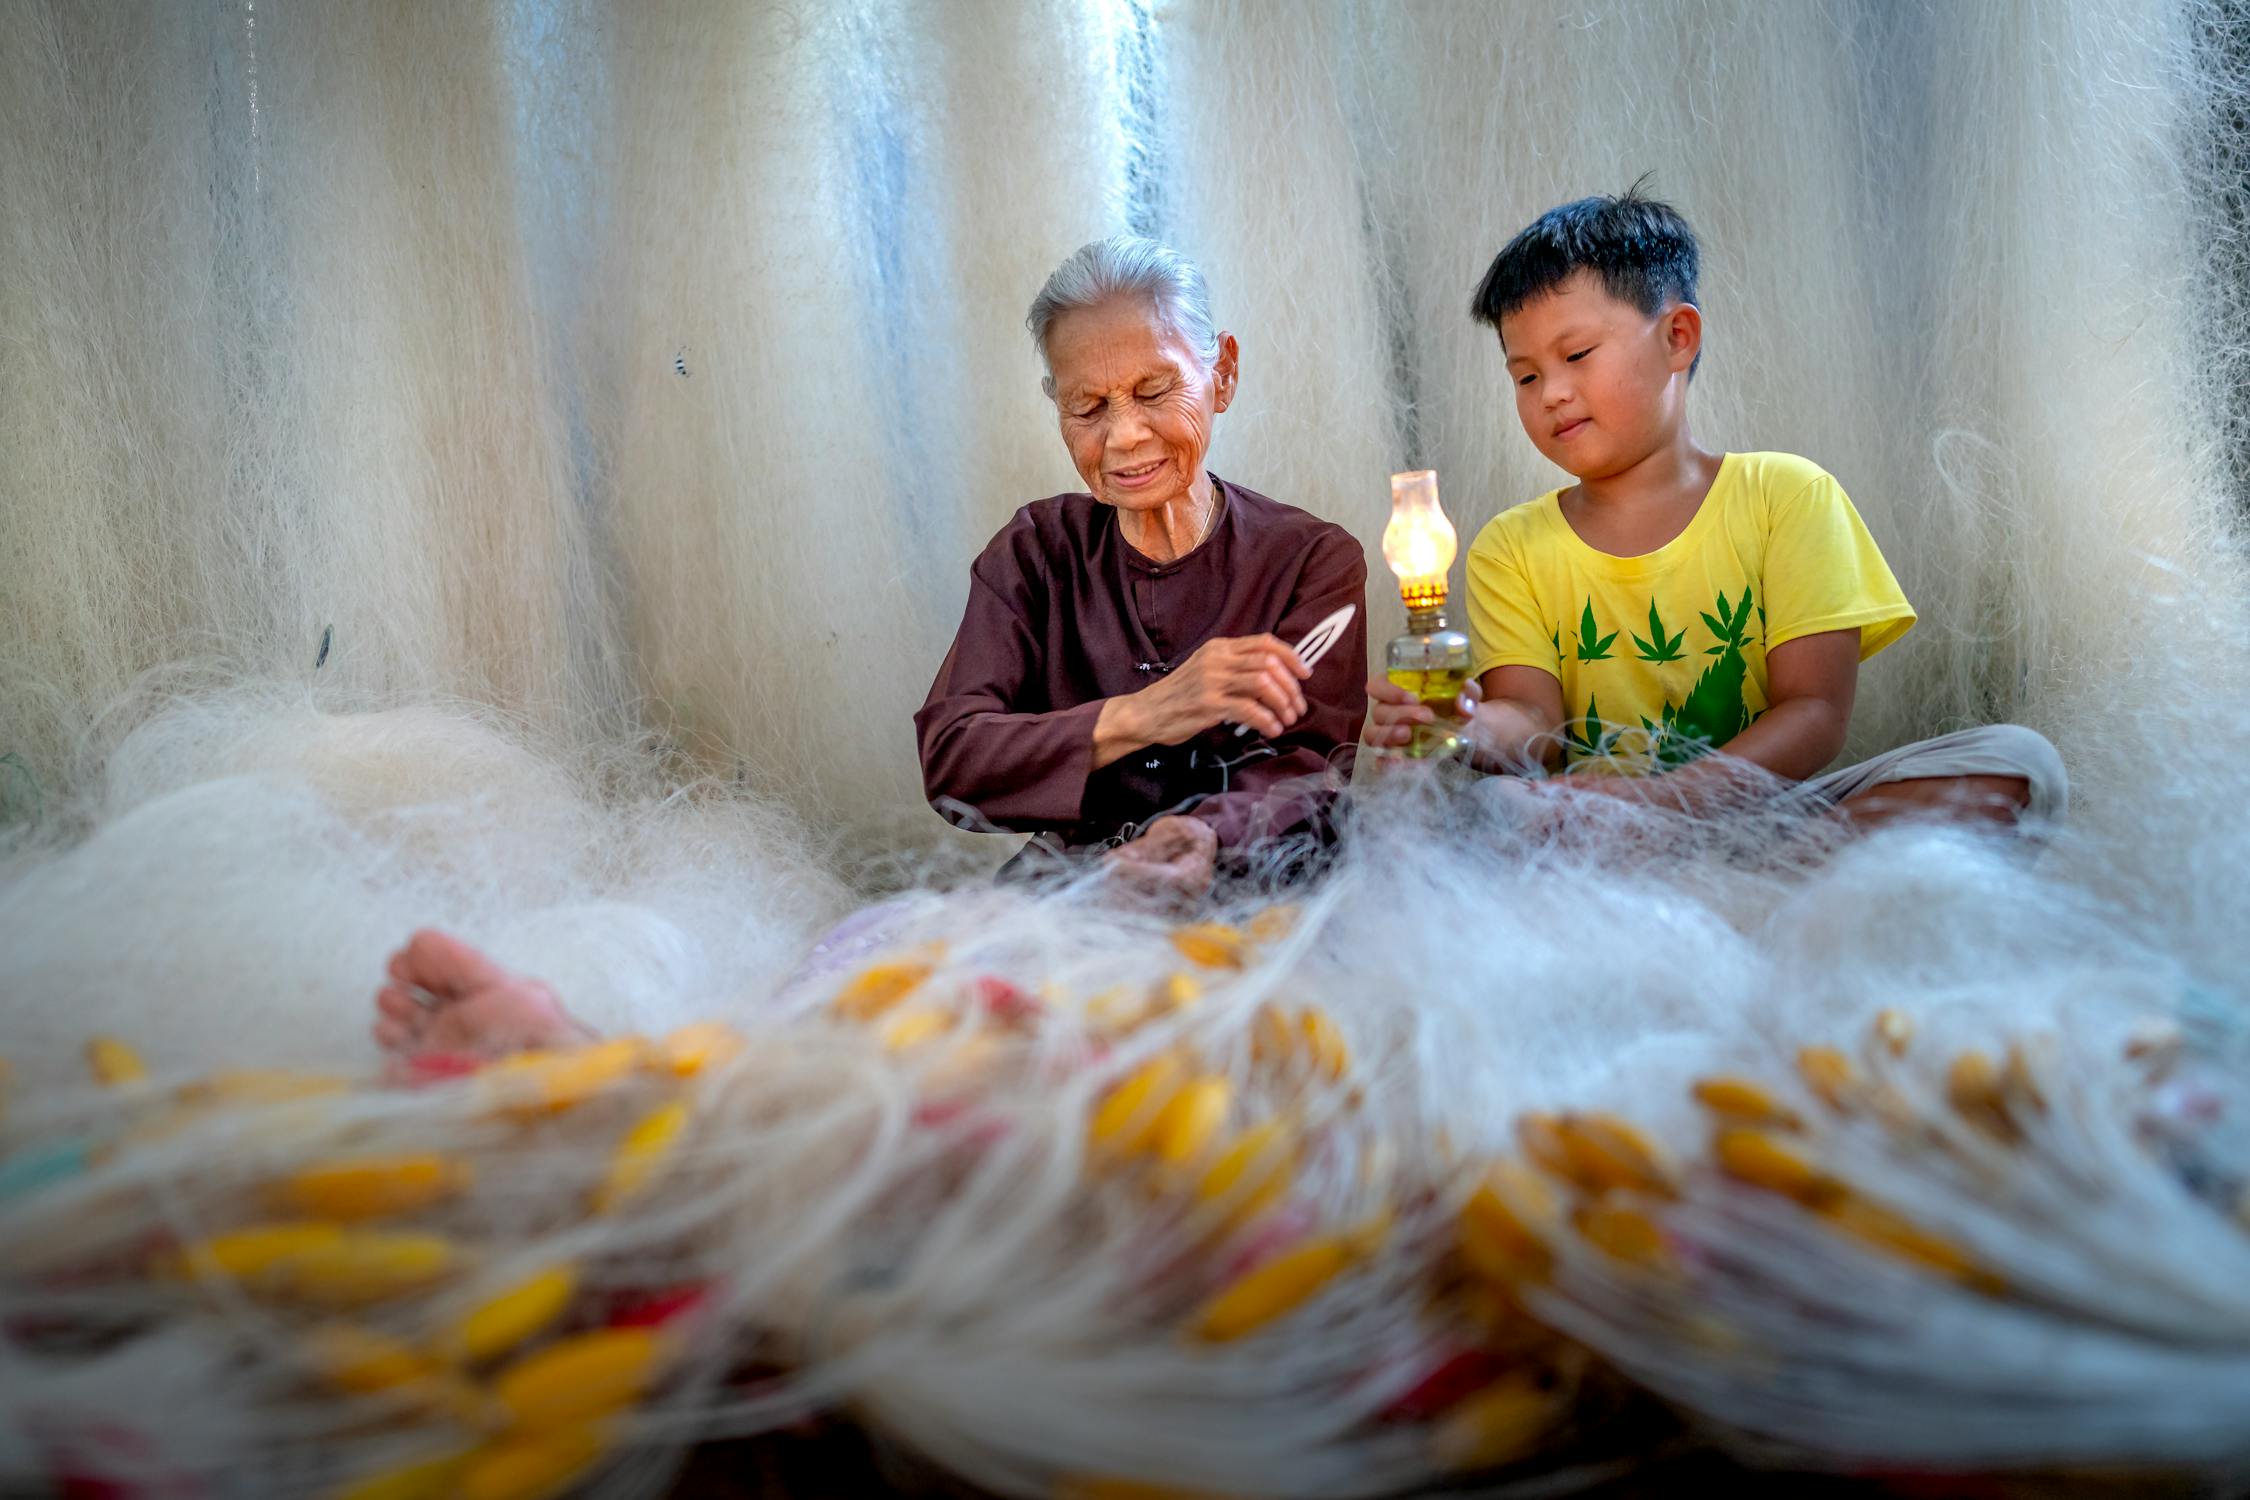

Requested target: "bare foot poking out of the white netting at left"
[{"left": 376, "top": 929, "right": 594, "bottom": 1079}]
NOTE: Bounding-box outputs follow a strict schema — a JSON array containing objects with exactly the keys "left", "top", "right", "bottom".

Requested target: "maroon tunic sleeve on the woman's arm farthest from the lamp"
[{"left": 914, "top": 535, "right": 1103, "bottom": 832}]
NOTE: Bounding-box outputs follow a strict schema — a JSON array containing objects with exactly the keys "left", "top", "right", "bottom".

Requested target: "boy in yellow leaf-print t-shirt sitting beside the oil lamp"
[{"left": 1368, "top": 189, "right": 2068, "bottom": 825}]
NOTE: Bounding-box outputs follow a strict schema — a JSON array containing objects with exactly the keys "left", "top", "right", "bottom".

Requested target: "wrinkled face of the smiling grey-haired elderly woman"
[{"left": 1046, "top": 297, "right": 1238, "bottom": 510}]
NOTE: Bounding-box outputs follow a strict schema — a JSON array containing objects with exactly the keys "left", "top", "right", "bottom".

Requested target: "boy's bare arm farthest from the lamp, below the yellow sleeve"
[{"left": 1571, "top": 625, "right": 1859, "bottom": 812}]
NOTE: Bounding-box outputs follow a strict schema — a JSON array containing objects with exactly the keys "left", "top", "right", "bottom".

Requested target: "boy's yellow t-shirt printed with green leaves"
[{"left": 1469, "top": 452, "right": 1915, "bottom": 771}]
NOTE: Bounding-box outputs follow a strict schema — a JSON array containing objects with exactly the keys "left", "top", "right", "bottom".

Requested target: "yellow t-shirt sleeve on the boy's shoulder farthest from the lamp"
[{"left": 1766, "top": 475, "right": 1915, "bottom": 661}]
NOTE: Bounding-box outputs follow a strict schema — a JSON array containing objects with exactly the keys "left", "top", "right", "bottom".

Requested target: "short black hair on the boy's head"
[{"left": 1469, "top": 178, "right": 1703, "bottom": 376}]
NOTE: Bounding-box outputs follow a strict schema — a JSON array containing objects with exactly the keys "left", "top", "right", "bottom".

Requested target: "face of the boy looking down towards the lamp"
[{"left": 1501, "top": 272, "right": 1703, "bottom": 479}]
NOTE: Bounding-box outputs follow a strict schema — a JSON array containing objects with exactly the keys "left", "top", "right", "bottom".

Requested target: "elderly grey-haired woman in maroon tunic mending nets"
[{"left": 914, "top": 236, "right": 1368, "bottom": 891}]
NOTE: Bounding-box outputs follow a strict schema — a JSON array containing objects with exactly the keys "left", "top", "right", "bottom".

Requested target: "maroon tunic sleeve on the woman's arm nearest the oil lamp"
[{"left": 1190, "top": 531, "right": 1368, "bottom": 848}]
